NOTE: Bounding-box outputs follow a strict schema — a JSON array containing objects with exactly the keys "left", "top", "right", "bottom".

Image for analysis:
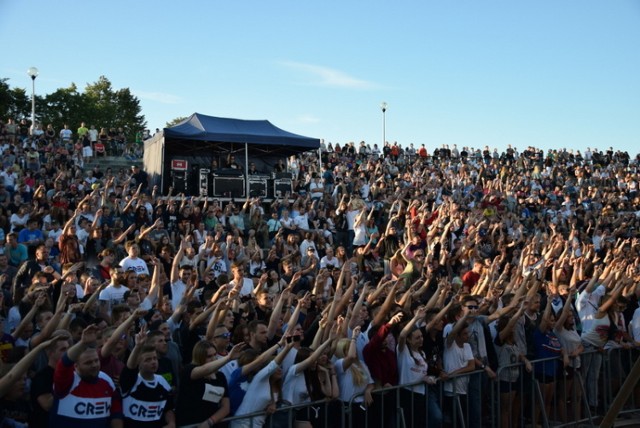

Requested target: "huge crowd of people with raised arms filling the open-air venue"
[{"left": 0, "top": 115, "right": 640, "bottom": 428}]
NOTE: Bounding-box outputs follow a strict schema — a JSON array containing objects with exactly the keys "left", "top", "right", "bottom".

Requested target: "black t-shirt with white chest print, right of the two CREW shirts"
[{"left": 176, "top": 364, "right": 229, "bottom": 426}]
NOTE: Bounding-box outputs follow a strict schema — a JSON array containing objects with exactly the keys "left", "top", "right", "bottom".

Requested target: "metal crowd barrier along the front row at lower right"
[{"left": 219, "top": 348, "right": 640, "bottom": 428}]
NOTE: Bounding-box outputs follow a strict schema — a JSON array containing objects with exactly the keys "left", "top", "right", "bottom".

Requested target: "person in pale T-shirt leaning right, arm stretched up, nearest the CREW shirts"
[{"left": 230, "top": 342, "right": 293, "bottom": 428}]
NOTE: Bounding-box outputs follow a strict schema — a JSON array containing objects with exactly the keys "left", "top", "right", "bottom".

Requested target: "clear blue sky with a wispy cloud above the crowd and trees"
[{"left": 0, "top": 0, "right": 640, "bottom": 154}]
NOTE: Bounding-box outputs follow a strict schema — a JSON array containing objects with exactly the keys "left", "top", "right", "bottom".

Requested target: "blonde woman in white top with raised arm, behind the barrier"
[{"left": 335, "top": 327, "right": 374, "bottom": 427}]
